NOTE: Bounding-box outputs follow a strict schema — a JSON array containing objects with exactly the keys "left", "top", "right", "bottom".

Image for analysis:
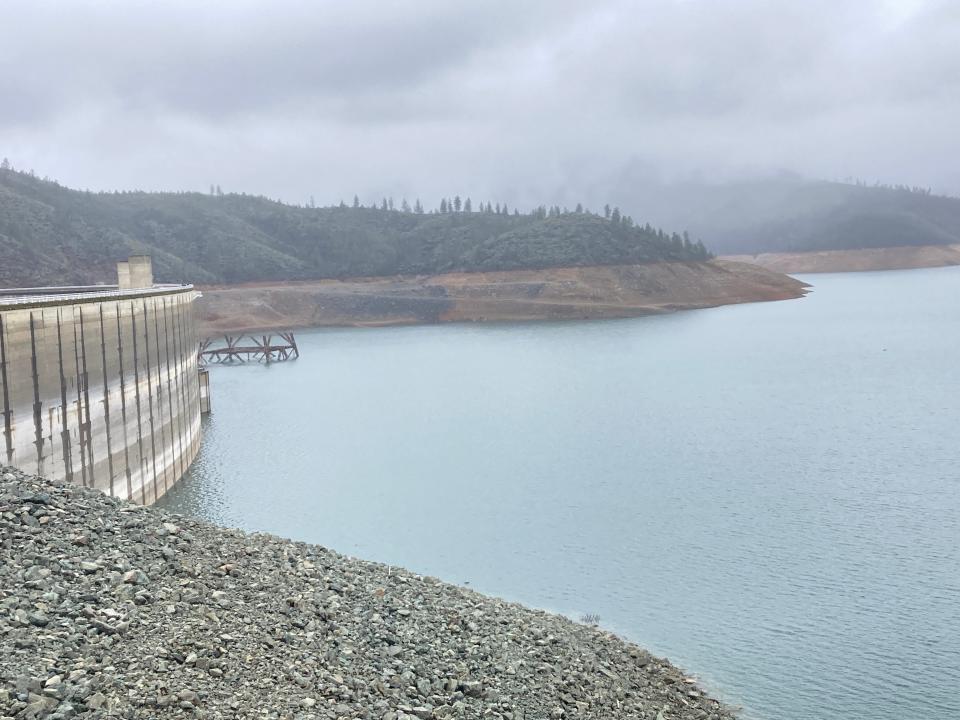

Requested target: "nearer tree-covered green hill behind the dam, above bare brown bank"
[{"left": 0, "top": 168, "right": 709, "bottom": 286}]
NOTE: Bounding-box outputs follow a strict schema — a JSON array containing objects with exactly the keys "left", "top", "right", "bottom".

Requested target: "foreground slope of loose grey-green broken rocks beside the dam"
[{"left": 0, "top": 469, "right": 733, "bottom": 720}]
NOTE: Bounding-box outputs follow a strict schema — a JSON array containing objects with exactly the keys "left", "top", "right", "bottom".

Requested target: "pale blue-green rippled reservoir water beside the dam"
[{"left": 162, "top": 268, "right": 960, "bottom": 720}]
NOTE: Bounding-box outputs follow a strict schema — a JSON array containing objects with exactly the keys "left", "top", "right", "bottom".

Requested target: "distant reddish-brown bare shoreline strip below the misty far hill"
[{"left": 724, "top": 245, "right": 960, "bottom": 273}]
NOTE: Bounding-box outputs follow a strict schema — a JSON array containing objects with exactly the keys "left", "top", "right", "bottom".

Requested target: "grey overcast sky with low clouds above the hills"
[{"left": 0, "top": 0, "right": 960, "bottom": 205}]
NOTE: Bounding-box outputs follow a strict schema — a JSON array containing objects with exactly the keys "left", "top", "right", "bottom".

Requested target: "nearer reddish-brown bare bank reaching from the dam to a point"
[{"left": 198, "top": 260, "right": 808, "bottom": 336}]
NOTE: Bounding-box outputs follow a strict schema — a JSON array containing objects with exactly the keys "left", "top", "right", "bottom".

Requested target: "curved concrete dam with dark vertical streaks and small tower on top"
[{"left": 0, "top": 257, "right": 200, "bottom": 504}]
